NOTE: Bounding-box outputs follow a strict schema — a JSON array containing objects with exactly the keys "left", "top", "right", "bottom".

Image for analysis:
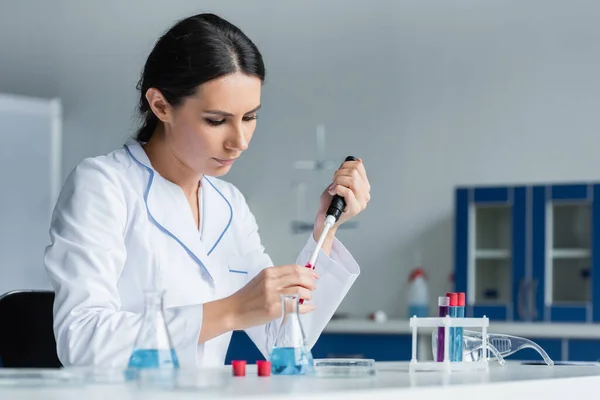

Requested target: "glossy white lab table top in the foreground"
[{"left": 0, "top": 362, "right": 600, "bottom": 400}]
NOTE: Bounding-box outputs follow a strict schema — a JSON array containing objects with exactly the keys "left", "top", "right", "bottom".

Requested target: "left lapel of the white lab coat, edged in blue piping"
[{"left": 126, "top": 142, "right": 219, "bottom": 284}]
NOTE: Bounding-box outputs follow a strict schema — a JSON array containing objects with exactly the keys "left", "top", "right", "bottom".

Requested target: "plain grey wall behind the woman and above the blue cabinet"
[{"left": 0, "top": 0, "right": 600, "bottom": 315}]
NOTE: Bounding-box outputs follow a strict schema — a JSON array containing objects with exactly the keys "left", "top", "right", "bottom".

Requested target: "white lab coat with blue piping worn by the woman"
[{"left": 45, "top": 141, "right": 359, "bottom": 367}]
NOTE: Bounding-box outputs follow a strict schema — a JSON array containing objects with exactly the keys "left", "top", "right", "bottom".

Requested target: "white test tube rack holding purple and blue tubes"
[{"left": 409, "top": 316, "right": 490, "bottom": 373}]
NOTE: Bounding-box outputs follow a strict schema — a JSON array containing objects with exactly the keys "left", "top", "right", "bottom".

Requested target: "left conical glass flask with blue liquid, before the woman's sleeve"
[{"left": 129, "top": 291, "right": 179, "bottom": 370}]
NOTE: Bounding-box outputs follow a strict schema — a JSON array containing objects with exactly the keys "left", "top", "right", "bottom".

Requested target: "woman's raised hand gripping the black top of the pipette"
[{"left": 314, "top": 158, "right": 371, "bottom": 236}]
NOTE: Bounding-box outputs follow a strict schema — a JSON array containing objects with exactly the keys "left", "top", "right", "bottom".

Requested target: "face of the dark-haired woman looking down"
[{"left": 165, "top": 72, "right": 262, "bottom": 176}]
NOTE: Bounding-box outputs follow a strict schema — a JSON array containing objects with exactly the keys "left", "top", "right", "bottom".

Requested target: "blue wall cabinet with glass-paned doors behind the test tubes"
[{"left": 454, "top": 183, "right": 600, "bottom": 322}]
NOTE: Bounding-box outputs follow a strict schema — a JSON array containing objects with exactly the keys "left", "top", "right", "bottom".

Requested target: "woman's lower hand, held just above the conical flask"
[{"left": 228, "top": 264, "right": 319, "bottom": 329}]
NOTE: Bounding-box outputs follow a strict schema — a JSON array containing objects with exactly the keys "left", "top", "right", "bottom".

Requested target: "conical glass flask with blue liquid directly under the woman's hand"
[{"left": 270, "top": 294, "right": 314, "bottom": 375}]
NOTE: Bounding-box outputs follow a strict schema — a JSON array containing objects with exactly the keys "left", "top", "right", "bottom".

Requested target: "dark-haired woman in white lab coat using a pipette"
[{"left": 45, "top": 14, "right": 370, "bottom": 367}]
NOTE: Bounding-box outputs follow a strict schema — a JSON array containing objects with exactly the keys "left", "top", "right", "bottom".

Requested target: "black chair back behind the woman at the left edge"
[{"left": 0, "top": 290, "right": 62, "bottom": 368}]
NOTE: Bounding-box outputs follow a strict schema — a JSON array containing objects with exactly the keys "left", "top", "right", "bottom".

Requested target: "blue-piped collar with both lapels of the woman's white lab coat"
[{"left": 125, "top": 140, "right": 233, "bottom": 283}]
